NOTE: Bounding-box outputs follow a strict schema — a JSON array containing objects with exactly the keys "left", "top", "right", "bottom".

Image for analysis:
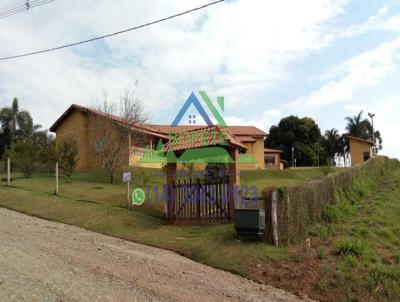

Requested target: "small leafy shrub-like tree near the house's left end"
[{"left": 57, "top": 137, "right": 78, "bottom": 178}]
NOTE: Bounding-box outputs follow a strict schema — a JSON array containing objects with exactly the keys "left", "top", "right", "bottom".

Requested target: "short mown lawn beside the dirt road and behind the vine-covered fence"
[{"left": 0, "top": 168, "right": 340, "bottom": 277}]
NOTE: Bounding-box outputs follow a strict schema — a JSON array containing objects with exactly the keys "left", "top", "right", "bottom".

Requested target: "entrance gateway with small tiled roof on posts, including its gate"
[{"left": 164, "top": 126, "right": 247, "bottom": 223}]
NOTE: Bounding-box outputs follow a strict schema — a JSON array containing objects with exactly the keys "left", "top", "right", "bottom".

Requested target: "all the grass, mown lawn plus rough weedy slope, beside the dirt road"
[{"left": 0, "top": 164, "right": 400, "bottom": 301}]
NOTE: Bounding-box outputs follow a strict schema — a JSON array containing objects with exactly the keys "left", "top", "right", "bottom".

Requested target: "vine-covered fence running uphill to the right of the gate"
[{"left": 263, "top": 156, "right": 399, "bottom": 245}]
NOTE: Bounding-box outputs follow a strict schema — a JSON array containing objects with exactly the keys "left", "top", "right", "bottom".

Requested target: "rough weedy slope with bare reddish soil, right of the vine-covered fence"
[{"left": 258, "top": 165, "right": 400, "bottom": 302}]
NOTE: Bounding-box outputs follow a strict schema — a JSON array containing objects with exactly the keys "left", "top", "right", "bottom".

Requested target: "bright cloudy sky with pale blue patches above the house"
[{"left": 0, "top": 0, "right": 400, "bottom": 158}]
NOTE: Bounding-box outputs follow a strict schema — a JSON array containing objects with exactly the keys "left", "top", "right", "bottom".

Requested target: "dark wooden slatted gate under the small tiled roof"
[{"left": 172, "top": 179, "right": 232, "bottom": 224}]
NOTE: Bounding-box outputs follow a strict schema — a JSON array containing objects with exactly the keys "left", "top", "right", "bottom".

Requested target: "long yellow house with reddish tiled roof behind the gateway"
[{"left": 50, "top": 104, "right": 267, "bottom": 171}]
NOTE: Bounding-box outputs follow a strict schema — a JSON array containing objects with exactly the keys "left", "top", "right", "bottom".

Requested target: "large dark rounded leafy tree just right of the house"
[{"left": 265, "top": 116, "right": 322, "bottom": 166}]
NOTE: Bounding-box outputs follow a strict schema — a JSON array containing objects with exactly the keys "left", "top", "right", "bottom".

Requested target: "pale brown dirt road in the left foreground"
[{"left": 0, "top": 208, "right": 299, "bottom": 301}]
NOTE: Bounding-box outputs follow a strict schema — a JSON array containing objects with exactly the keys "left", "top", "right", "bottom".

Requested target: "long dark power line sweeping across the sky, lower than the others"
[{"left": 0, "top": 0, "right": 225, "bottom": 61}]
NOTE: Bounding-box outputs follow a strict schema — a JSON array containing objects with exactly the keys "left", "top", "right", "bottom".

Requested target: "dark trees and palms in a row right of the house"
[{"left": 265, "top": 111, "right": 382, "bottom": 166}]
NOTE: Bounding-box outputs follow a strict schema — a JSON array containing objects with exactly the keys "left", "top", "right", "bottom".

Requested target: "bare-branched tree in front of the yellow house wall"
[{"left": 89, "top": 91, "right": 147, "bottom": 183}]
